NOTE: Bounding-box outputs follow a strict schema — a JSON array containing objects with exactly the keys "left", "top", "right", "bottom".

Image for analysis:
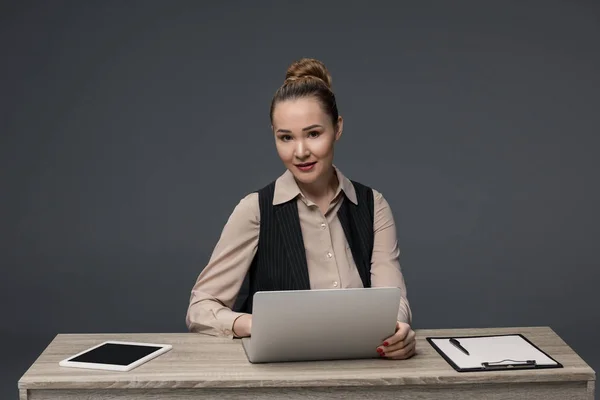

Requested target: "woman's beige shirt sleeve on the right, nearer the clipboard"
[{"left": 371, "top": 190, "right": 412, "bottom": 324}]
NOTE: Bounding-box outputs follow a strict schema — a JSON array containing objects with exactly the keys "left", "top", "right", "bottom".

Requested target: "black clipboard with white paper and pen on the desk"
[{"left": 426, "top": 333, "right": 563, "bottom": 372}]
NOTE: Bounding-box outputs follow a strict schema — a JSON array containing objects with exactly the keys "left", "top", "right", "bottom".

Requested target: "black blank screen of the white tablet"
[{"left": 69, "top": 343, "right": 161, "bottom": 366}]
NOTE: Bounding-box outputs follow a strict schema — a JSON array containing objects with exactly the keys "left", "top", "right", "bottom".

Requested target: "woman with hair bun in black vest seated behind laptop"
[{"left": 186, "top": 59, "right": 415, "bottom": 359}]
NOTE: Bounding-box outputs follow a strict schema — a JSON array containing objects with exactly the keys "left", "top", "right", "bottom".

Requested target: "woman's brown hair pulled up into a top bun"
[{"left": 270, "top": 58, "right": 338, "bottom": 126}]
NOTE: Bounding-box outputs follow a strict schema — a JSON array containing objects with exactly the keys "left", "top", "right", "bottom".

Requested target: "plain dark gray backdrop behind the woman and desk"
[{"left": 0, "top": 0, "right": 600, "bottom": 398}]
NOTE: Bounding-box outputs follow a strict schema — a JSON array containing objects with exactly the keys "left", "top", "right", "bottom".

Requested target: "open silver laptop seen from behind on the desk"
[{"left": 242, "top": 288, "right": 401, "bottom": 363}]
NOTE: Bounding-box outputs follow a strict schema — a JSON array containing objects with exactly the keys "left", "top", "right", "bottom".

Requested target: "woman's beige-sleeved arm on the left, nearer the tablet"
[{"left": 186, "top": 193, "right": 260, "bottom": 338}]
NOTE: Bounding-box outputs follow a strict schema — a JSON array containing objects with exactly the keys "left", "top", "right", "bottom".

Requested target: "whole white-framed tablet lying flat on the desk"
[{"left": 58, "top": 340, "right": 172, "bottom": 371}]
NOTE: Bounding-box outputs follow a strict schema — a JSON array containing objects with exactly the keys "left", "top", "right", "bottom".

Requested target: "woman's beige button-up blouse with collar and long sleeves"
[{"left": 186, "top": 168, "right": 412, "bottom": 338}]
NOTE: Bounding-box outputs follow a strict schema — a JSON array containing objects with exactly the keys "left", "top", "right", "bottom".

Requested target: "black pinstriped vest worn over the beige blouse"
[{"left": 233, "top": 181, "right": 374, "bottom": 313}]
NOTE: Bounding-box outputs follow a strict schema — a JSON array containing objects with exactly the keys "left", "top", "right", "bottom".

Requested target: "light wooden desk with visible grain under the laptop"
[{"left": 19, "top": 327, "right": 596, "bottom": 400}]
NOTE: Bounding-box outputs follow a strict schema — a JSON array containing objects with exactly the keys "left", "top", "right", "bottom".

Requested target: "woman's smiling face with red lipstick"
[{"left": 273, "top": 97, "right": 342, "bottom": 185}]
